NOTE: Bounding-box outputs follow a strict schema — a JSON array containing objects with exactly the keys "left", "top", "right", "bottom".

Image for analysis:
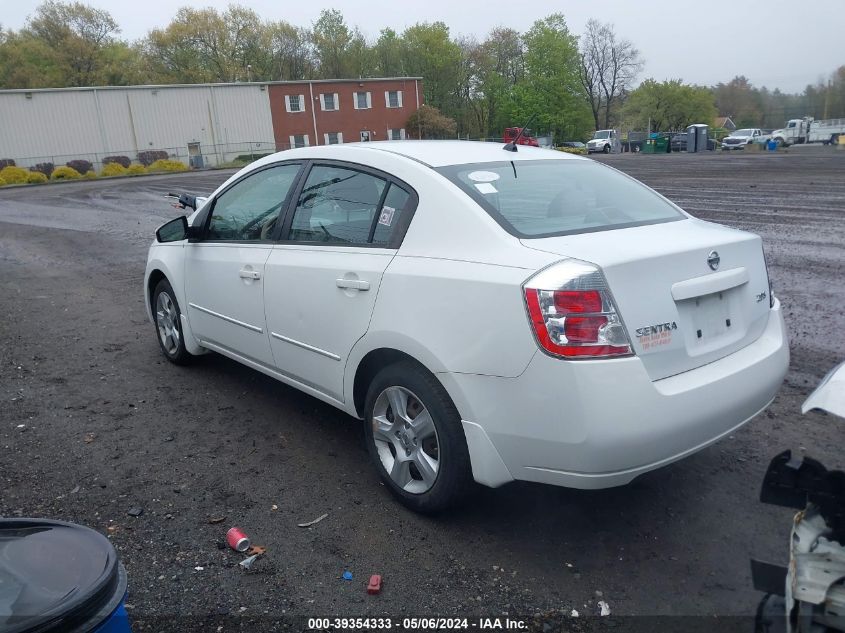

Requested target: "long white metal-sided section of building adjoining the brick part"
[{"left": 0, "top": 83, "right": 275, "bottom": 169}]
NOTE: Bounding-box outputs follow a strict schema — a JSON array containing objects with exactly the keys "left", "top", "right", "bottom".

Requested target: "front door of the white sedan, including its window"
[{"left": 185, "top": 163, "right": 301, "bottom": 366}]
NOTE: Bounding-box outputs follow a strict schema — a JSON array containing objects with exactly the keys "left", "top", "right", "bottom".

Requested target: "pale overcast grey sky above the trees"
[{"left": 0, "top": 0, "right": 845, "bottom": 92}]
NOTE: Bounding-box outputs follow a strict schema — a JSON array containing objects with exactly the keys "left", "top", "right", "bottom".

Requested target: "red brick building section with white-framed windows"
[{"left": 268, "top": 77, "right": 423, "bottom": 149}]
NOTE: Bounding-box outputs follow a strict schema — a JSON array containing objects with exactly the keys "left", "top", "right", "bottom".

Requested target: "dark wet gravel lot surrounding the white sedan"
[{"left": 0, "top": 147, "right": 845, "bottom": 630}]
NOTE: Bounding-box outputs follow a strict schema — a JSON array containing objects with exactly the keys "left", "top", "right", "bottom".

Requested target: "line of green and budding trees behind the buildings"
[{"left": 0, "top": 0, "right": 845, "bottom": 140}]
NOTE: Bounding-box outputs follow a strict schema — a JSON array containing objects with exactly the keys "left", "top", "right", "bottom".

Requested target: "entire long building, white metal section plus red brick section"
[{"left": 0, "top": 77, "right": 423, "bottom": 169}]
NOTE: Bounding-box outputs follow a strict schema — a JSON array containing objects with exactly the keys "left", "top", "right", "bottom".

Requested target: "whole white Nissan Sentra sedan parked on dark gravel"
[{"left": 144, "top": 141, "right": 789, "bottom": 511}]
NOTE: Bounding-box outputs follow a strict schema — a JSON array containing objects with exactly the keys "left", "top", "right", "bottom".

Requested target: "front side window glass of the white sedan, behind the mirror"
[{"left": 206, "top": 163, "right": 300, "bottom": 241}]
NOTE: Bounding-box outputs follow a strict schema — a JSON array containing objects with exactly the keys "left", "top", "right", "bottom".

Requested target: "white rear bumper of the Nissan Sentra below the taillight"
[{"left": 442, "top": 302, "right": 789, "bottom": 489}]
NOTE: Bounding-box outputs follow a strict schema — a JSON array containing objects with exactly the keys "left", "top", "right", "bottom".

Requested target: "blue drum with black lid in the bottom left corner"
[{"left": 0, "top": 519, "right": 130, "bottom": 633}]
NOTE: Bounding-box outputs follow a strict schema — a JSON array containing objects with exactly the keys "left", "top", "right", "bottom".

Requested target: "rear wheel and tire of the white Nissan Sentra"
[{"left": 364, "top": 361, "right": 472, "bottom": 514}]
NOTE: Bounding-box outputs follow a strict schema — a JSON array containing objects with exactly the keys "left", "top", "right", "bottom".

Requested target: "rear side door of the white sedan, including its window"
[{"left": 265, "top": 162, "right": 417, "bottom": 400}]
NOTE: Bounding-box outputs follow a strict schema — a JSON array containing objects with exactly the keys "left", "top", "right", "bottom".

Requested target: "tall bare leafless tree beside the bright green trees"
[{"left": 580, "top": 20, "right": 643, "bottom": 129}]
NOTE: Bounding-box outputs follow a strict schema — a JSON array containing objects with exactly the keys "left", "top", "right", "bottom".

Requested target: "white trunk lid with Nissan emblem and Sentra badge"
[{"left": 521, "top": 218, "right": 769, "bottom": 380}]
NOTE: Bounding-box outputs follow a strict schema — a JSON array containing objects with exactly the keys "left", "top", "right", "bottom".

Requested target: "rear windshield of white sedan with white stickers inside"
[{"left": 438, "top": 160, "right": 685, "bottom": 238}]
